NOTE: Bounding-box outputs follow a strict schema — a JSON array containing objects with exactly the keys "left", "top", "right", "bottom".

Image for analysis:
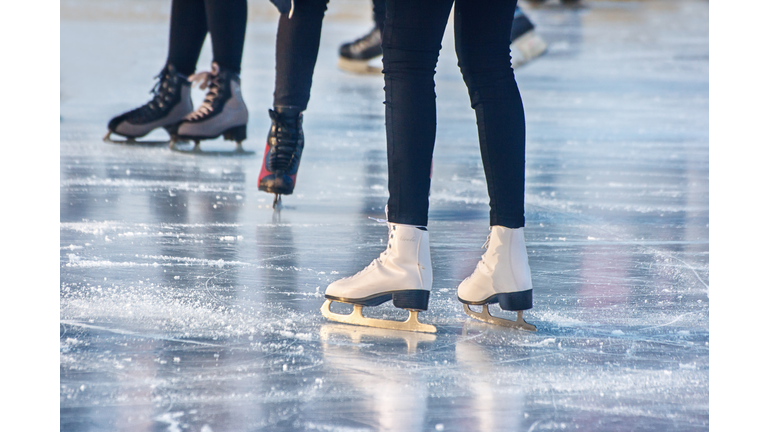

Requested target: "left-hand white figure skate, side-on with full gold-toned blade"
[{"left": 321, "top": 222, "right": 436, "bottom": 333}]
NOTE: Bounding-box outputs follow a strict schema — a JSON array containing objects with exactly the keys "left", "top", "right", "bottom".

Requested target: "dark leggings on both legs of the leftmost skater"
[{"left": 168, "top": 0, "right": 248, "bottom": 75}]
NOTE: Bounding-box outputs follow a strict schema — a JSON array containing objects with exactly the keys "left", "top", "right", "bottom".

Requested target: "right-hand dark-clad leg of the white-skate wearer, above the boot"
[{"left": 454, "top": 0, "right": 525, "bottom": 228}]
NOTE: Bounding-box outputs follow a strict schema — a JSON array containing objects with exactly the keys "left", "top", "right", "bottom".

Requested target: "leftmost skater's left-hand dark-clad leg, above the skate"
[{"left": 167, "top": 0, "right": 208, "bottom": 76}]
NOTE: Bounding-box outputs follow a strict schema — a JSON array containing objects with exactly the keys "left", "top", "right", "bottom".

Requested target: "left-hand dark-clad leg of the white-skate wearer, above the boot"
[{"left": 382, "top": 0, "right": 452, "bottom": 226}]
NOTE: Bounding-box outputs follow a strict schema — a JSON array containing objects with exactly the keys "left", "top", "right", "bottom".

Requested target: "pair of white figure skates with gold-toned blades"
[{"left": 321, "top": 222, "right": 536, "bottom": 333}]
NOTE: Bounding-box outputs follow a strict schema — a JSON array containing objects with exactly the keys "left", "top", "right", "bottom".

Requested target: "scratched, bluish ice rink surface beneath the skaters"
[{"left": 60, "top": 0, "right": 709, "bottom": 432}]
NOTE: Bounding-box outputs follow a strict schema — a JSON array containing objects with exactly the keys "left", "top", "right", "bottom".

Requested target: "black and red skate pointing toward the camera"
[{"left": 259, "top": 107, "right": 304, "bottom": 208}]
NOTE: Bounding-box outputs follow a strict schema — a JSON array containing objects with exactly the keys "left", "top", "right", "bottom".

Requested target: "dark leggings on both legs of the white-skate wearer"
[{"left": 382, "top": 0, "right": 525, "bottom": 228}]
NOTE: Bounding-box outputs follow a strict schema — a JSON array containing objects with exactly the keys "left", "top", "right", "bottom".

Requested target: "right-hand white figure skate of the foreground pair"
[{"left": 458, "top": 225, "right": 536, "bottom": 331}]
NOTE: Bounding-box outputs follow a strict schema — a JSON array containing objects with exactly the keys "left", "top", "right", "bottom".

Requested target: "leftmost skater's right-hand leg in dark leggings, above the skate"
[{"left": 205, "top": 0, "right": 248, "bottom": 74}]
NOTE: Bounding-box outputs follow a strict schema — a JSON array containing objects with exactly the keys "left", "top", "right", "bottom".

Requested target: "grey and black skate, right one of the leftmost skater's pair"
[{"left": 171, "top": 62, "right": 253, "bottom": 155}]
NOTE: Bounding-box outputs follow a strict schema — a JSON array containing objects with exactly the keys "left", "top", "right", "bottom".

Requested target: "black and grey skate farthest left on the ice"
[{"left": 104, "top": 64, "right": 194, "bottom": 145}]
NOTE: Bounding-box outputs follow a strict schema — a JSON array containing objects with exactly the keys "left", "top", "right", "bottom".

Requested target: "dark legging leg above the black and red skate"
[{"left": 274, "top": 0, "right": 328, "bottom": 111}]
